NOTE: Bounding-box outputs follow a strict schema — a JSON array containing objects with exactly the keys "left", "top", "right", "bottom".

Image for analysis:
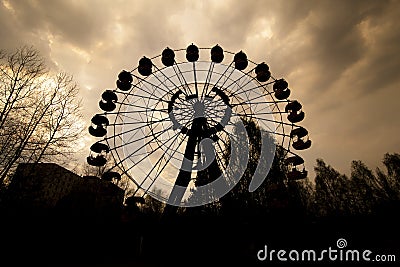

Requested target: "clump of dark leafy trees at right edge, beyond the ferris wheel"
[{"left": 310, "top": 153, "right": 400, "bottom": 217}]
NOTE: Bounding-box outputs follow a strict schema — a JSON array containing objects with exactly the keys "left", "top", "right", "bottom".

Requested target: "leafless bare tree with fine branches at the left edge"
[{"left": 0, "top": 46, "right": 83, "bottom": 184}]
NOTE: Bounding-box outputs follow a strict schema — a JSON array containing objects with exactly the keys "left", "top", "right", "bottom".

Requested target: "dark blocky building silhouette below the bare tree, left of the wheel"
[{"left": 3, "top": 163, "right": 124, "bottom": 221}]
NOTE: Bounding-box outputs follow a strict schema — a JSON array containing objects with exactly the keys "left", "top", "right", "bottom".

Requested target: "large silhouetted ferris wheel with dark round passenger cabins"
[{"left": 87, "top": 44, "right": 311, "bottom": 206}]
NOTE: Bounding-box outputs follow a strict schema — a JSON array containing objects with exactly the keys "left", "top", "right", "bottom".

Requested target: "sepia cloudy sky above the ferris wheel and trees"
[{"left": 0, "top": 0, "right": 400, "bottom": 180}]
